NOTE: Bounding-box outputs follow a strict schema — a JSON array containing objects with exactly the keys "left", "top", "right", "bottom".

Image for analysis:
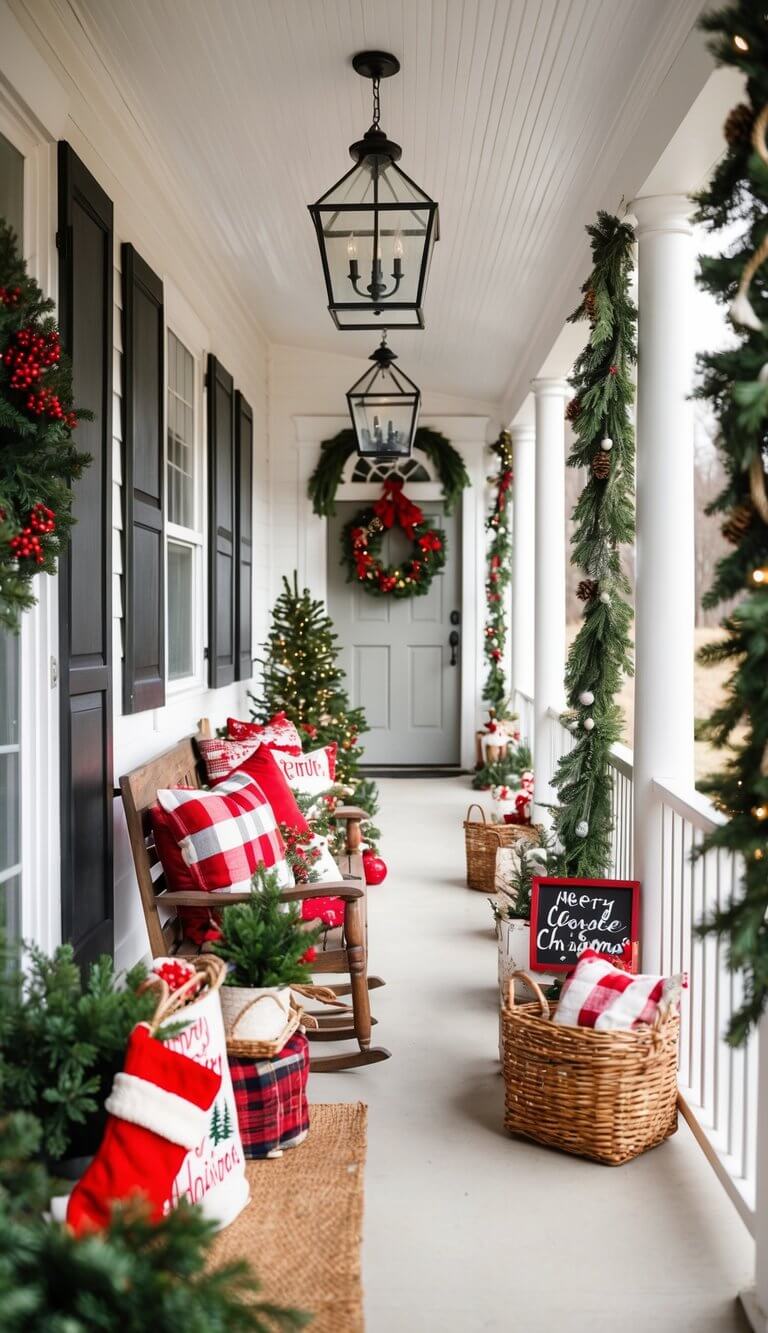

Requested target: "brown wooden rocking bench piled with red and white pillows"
[{"left": 120, "top": 722, "right": 389, "bottom": 1072}]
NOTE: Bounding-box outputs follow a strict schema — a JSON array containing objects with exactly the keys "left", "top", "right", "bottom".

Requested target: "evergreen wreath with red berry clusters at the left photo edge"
[{"left": 0, "top": 219, "right": 91, "bottom": 632}]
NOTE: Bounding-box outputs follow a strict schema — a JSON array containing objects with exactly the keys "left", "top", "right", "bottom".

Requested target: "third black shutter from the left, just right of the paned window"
[{"left": 207, "top": 356, "right": 237, "bottom": 689}]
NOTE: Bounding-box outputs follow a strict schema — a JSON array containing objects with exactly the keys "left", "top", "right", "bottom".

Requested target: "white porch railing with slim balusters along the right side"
[{"left": 533, "top": 692, "right": 759, "bottom": 1233}]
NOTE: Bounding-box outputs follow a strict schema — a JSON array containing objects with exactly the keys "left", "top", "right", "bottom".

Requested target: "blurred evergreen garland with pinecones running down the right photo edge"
[{"left": 697, "top": 0, "right": 768, "bottom": 1045}]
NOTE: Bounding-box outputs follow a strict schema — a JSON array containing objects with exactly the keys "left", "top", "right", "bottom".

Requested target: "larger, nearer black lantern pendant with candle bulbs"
[{"left": 309, "top": 51, "right": 439, "bottom": 329}]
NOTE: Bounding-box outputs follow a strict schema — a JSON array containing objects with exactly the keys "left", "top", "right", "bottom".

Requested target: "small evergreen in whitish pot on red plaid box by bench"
[{"left": 215, "top": 866, "right": 321, "bottom": 1042}]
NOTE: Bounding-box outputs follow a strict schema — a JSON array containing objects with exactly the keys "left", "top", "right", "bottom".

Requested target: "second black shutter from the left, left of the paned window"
[{"left": 123, "top": 244, "right": 165, "bottom": 713}]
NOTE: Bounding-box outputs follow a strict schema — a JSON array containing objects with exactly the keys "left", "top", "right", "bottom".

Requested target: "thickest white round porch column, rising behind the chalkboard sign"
[{"left": 632, "top": 195, "right": 695, "bottom": 972}]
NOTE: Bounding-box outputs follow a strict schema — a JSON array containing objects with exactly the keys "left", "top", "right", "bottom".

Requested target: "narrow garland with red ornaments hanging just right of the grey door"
[{"left": 483, "top": 431, "right": 512, "bottom": 717}]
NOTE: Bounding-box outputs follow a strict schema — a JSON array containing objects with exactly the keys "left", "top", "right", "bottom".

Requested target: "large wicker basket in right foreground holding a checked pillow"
[{"left": 501, "top": 972, "right": 680, "bottom": 1166}]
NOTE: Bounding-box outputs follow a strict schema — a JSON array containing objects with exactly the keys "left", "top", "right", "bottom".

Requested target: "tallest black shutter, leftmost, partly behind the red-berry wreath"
[{"left": 57, "top": 143, "right": 113, "bottom": 964}]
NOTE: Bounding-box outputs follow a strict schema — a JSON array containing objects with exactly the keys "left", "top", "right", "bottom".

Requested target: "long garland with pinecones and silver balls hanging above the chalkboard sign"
[{"left": 553, "top": 212, "right": 637, "bottom": 877}]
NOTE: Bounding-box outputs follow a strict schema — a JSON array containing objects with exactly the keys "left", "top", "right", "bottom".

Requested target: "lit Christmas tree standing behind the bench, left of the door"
[{"left": 249, "top": 573, "right": 377, "bottom": 821}]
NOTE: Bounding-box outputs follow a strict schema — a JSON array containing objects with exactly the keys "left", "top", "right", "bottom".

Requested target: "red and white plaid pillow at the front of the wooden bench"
[{"left": 157, "top": 773, "right": 293, "bottom": 893}]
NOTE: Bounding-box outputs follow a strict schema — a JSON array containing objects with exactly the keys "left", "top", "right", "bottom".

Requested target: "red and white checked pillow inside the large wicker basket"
[{"left": 555, "top": 949, "right": 688, "bottom": 1032}]
